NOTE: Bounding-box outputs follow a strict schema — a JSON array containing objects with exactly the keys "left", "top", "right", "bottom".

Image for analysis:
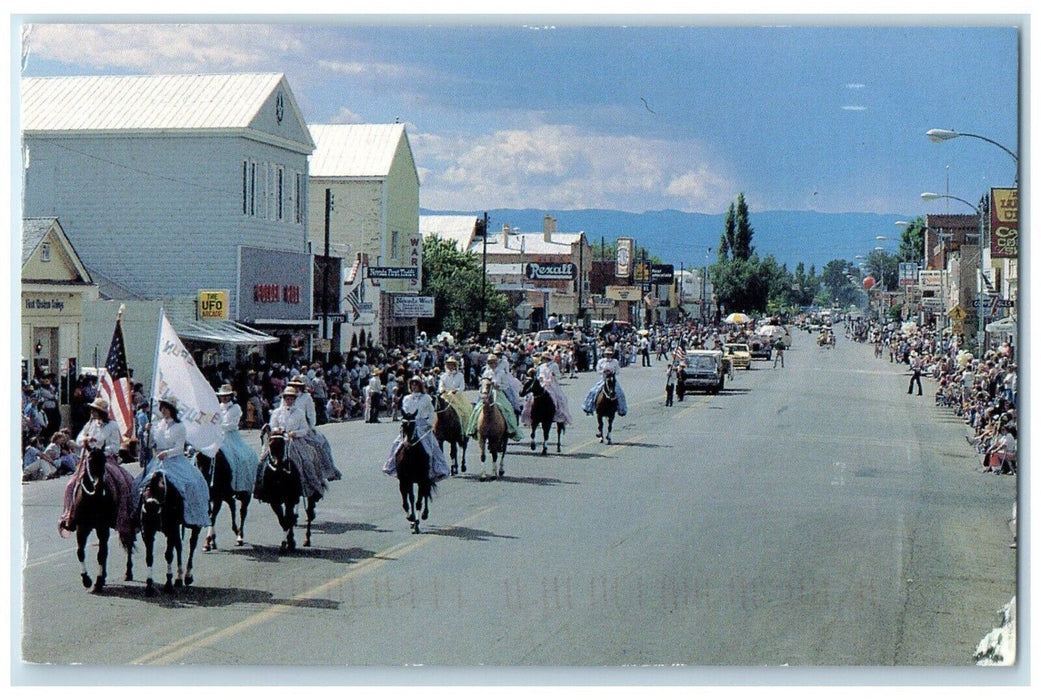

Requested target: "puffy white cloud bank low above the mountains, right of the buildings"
[{"left": 410, "top": 125, "right": 735, "bottom": 211}]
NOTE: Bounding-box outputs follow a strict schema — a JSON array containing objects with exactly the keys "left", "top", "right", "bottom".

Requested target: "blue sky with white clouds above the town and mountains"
[{"left": 16, "top": 16, "right": 1021, "bottom": 216}]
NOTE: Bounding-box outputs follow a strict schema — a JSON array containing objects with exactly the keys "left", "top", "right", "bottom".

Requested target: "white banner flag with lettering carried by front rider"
[{"left": 152, "top": 311, "right": 224, "bottom": 457}]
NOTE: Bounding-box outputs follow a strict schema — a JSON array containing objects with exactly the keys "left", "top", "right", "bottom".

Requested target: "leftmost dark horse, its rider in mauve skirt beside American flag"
[{"left": 73, "top": 449, "right": 135, "bottom": 593}]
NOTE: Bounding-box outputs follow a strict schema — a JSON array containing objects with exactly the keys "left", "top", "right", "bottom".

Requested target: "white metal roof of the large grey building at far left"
[{"left": 21, "top": 73, "right": 283, "bottom": 131}]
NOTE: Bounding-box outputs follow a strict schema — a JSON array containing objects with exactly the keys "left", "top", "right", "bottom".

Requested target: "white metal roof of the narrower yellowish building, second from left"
[{"left": 307, "top": 124, "right": 405, "bottom": 177}]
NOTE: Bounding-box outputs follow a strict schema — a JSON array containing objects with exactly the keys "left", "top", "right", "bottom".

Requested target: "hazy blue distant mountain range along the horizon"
[{"left": 421, "top": 209, "right": 914, "bottom": 272}]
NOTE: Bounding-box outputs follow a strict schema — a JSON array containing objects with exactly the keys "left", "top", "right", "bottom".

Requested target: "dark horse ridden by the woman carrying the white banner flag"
[{"left": 138, "top": 469, "right": 202, "bottom": 596}]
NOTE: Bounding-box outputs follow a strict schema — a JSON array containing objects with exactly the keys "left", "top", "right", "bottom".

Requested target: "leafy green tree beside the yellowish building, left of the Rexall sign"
[{"left": 418, "top": 235, "right": 513, "bottom": 338}]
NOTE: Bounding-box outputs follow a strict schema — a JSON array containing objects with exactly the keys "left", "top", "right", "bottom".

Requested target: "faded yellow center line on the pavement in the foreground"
[{"left": 130, "top": 505, "right": 499, "bottom": 665}]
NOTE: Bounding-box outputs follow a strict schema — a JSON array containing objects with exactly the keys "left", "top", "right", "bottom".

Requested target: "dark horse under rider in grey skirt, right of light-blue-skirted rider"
[{"left": 254, "top": 426, "right": 322, "bottom": 553}]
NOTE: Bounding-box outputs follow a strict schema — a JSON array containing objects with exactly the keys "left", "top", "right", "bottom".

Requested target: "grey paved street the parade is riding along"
[{"left": 16, "top": 332, "right": 1016, "bottom": 682}]
